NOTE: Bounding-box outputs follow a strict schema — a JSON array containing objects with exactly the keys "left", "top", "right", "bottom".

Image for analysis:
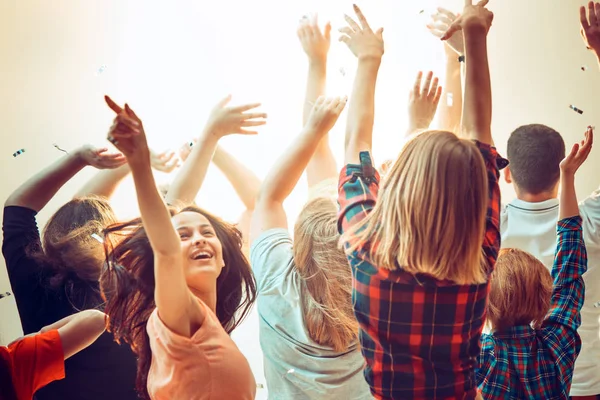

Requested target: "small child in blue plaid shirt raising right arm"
[{"left": 476, "top": 128, "right": 593, "bottom": 399}]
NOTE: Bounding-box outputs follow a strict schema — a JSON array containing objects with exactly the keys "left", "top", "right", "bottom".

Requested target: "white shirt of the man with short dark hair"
[{"left": 501, "top": 190, "right": 600, "bottom": 396}]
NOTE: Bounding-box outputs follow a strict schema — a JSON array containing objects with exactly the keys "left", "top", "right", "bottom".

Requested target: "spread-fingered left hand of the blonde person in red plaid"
[{"left": 340, "top": 4, "right": 384, "bottom": 59}]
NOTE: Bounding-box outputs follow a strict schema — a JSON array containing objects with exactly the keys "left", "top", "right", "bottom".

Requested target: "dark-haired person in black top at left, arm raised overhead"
[{"left": 2, "top": 146, "right": 137, "bottom": 400}]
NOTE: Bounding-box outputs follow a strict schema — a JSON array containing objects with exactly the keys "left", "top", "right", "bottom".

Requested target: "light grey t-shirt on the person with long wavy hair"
[{"left": 250, "top": 229, "right": 373, "bottom": 400}]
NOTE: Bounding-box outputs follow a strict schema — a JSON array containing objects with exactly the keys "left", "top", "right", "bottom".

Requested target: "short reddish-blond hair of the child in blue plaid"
[{"left": 487, "top": 249, "right": 553, "bottom": 331}]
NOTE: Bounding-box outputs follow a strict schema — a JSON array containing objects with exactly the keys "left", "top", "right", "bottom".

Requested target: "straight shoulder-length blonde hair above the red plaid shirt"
[{"left": 343, "top": 131, "right": 489, "bottom": 285}]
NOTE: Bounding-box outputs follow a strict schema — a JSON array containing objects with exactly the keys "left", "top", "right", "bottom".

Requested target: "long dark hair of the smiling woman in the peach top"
[{"left": 100, "top": 206, "right": 256, "bottom": 399}]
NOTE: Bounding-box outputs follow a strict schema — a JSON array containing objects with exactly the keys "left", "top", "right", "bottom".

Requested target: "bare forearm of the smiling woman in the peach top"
[{"left": 129, "top": 160, "right": 181, "bottom": 256}]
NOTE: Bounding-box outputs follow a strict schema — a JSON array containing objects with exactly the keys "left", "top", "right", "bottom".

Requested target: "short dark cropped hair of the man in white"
[{"left": 507, "top": 124, "right": 565, "bottom": 194}]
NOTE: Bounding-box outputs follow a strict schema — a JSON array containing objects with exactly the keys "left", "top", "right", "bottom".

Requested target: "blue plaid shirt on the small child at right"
[{"left": 476, "top": 217, "right": 587, "bottom": 399}]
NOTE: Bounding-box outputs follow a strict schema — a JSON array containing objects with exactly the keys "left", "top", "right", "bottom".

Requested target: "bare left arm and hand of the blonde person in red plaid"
[{"left": 340, "top": 5, "right": 384, "bottom": 164}]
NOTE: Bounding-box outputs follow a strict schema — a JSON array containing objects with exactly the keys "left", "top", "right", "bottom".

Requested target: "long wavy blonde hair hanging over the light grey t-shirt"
[{"left": 293, "top": 197, "right": 358, "bottom": 351}]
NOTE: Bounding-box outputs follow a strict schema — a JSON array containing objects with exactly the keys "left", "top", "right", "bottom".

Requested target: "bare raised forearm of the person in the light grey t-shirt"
[{"left": 257, "top": 130, "right": 323, "bottom": 203}]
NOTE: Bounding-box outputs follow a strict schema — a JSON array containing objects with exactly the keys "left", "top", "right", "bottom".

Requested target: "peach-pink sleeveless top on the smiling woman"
[{"left": 146, "top": 302, "right": 256, "bottom": 400}]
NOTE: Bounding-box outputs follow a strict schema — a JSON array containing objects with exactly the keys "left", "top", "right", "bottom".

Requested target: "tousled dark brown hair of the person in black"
[{"left": 27, "top": 196, "right": 117, "bottom": 311}]
